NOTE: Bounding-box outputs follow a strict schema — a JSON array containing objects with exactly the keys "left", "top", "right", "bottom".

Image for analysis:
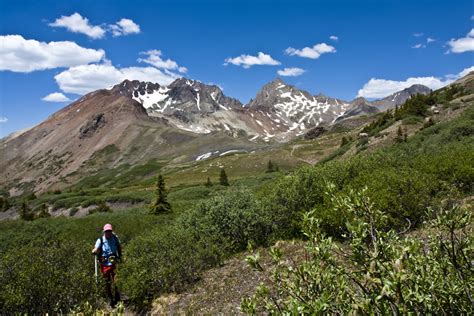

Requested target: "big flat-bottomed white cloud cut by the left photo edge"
[{"left": 0, "top": 35, "right": 105, "bottom": 72}]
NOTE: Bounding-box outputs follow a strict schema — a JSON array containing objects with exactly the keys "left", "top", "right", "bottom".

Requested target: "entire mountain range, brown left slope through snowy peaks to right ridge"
[{"left": 0, "top": 78, "right": 431, "bottom": 195}]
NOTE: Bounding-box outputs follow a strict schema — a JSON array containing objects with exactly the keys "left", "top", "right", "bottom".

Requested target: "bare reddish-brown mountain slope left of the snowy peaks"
[{"left": 0, "top": 86, "right": 266, "bottom": 196}]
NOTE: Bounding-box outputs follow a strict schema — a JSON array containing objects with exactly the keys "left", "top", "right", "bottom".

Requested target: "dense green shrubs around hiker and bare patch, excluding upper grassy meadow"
[{"left": 0, "top": 84, "right": 474, "bottom": 313}]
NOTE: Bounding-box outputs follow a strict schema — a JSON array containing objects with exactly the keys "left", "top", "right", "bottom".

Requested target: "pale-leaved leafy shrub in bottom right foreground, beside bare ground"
[{"left": 241, "top": 188, "right": 474, "bottom": 315}]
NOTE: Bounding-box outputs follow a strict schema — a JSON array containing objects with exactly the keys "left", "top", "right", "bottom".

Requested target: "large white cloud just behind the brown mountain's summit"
[{"left": 54, "top": 64, "right": 180, "bottom": 94}]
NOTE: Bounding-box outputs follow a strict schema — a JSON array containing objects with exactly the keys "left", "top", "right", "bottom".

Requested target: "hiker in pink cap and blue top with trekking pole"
[{"left": 92, "top": 224, "right": 122, "bottom": 307}]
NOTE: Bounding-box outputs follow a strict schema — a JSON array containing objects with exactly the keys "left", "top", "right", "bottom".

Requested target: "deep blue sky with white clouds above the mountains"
[{"left": 0, "top": 0, "right": 474, "bottom": 137}]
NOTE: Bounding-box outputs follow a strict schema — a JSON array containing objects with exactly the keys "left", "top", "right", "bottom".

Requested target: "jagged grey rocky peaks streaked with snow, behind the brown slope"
[{"left": 107, "top": 78, "right": 350, "bottom": 142}]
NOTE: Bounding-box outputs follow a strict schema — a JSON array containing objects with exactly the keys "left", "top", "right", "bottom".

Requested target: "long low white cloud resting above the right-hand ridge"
[{"left": 357, "top": 66, "right": 474, "bottom": 98}]
